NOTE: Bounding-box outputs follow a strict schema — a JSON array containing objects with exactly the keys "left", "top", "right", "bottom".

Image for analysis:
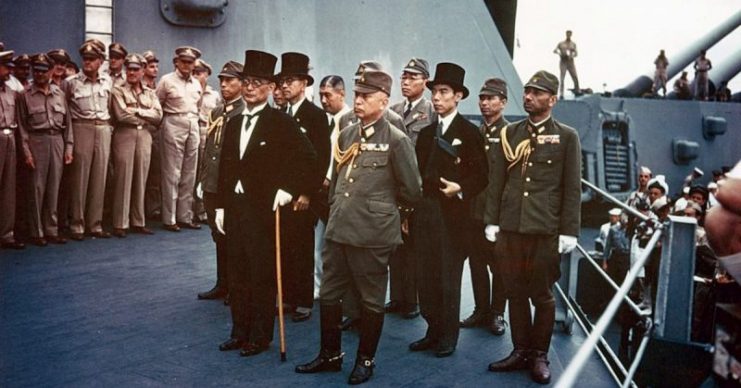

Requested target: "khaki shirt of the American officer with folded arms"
[{"left": 111, "top": 83, "right": 162, "bottom": 131}]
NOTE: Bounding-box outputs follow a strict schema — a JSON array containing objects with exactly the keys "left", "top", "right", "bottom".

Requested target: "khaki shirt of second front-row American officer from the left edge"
[{"left": 18, "top": 82, "right": 73, "bottom": 156}]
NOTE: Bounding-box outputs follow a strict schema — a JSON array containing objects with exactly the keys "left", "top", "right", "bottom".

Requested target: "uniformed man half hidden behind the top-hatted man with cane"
[{"left": 196, "top": 61, "right": 244, "bottom": 299}]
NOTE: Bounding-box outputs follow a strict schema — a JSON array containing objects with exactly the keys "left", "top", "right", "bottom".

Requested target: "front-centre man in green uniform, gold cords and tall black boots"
[{"left": 296, "top": 65, "right": 421, "bottom": 384}]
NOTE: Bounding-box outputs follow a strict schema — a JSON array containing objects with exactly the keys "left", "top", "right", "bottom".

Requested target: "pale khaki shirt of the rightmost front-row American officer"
[{"left": 156, "top": 71, "right": 203, "bottom": 116}]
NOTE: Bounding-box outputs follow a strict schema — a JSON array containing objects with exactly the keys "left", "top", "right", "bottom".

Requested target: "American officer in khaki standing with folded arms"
[{"left": 111, "top": 53, "right": 162, "bottom": 237}]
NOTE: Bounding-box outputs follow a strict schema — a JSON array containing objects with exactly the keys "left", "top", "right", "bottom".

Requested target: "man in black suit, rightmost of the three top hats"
[{"left": 409, "top": 63, "right": 488, "bottom": 357}]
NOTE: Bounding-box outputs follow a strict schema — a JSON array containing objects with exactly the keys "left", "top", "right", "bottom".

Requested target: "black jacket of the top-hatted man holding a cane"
[{"left": 216, "top": 106, "right": 316, "bottom": 226}]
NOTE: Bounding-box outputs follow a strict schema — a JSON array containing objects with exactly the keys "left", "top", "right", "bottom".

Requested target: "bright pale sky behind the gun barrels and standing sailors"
[{"left": 514, "top": 0, "right": 741, "bottom": 93}]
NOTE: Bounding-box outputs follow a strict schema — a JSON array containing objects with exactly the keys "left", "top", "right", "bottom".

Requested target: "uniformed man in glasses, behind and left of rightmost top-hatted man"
[{"left": 386, "top": 58, "right": 437, "bottom": 319}]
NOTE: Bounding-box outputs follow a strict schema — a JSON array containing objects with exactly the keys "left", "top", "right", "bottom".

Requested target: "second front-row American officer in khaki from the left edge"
[{"left": 18, "top": 54, "right": 73, "bottom": 246}]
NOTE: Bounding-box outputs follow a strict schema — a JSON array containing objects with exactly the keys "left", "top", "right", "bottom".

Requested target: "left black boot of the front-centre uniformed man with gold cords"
[{"left": 295, "top": 304, "right": 344, "bottom": 373}]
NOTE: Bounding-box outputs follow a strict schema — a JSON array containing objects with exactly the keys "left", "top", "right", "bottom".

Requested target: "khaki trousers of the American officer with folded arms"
[{"left": 111, "top": 127, "right": 152, "bottom": 229}]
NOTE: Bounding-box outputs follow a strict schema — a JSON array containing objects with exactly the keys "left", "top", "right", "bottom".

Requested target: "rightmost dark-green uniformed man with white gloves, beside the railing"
[{"left": 484, "top": 71, "right": 581, "bottom": 384}]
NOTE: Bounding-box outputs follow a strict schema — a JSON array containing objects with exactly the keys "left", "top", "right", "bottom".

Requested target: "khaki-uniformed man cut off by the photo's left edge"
[{"left": 0, "top": 51, "right": 25, "bottom": 249}]
